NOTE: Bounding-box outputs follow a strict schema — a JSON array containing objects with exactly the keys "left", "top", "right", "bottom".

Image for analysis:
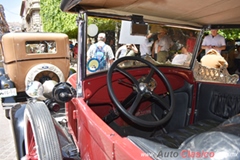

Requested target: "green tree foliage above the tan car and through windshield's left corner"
[{"left": 40, "top": 0, "right": 117, "bottom": 38}]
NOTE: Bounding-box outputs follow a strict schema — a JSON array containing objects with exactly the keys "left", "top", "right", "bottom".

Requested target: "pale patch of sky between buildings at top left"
[{"left": 0, "top": 0, "right": 22, "bottom": 23}]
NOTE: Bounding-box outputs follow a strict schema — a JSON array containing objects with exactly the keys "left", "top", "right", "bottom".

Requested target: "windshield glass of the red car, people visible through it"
[{"left": 86, "top": 17, "right": 200, "bottom": 74}]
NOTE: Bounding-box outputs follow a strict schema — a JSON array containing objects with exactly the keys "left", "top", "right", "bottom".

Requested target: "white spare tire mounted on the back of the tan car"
[{"left": 25, "top": 63, "right": 65, "bottom": 86}]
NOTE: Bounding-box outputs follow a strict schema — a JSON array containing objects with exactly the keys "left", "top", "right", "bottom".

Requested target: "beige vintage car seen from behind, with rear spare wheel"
[{"left": 0, "top": 33, "right": 70, "bottom": 115}]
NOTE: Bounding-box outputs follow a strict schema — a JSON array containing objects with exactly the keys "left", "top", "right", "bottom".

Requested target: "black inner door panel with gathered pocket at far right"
[{"left": 195, "top": 83, "right": 240, "bottom": 121}]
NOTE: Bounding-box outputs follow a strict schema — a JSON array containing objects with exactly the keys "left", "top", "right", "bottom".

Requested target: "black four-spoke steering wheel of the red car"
[{"left": 107, "top": 56, "right": 175, "bottom": 127}]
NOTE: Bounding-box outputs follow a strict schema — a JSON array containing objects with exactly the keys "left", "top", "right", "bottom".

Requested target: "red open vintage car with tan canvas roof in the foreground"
[{"left": 5, "top": 0, "right": 240, "bottom": 160}]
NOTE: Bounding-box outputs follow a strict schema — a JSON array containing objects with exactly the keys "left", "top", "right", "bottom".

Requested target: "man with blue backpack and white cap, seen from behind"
[{"left": 87, "top": 33, "right": 114, "bottom": 70}]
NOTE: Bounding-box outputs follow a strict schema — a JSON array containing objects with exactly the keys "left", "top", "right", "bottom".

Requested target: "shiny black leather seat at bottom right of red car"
[{"left": 128, "top": 114, "right": 240, "bottom": 160}]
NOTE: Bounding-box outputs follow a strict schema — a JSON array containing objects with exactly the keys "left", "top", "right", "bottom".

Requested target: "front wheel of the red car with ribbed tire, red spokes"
[{"left": 24, "top": 102, "right": 62, "bottom": 160}]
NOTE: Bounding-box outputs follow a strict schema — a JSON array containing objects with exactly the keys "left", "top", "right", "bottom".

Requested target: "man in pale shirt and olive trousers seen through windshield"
[{"left": 156, "top": 28, "right": 173, "bottom": 63}]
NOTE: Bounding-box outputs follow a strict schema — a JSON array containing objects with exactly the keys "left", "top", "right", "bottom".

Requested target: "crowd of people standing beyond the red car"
[{"left": 69, "top": 28, "right": 240, "bottom": 73}]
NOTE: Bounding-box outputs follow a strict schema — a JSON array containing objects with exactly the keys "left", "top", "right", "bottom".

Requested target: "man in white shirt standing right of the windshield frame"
[{"left": 202, "top": 29, "right": 226, "bottom": 53}]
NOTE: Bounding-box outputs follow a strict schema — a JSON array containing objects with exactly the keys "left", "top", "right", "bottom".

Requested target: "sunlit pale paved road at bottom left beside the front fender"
[{"left": 0, "top": 107, "right": 16, "bottom": 160}]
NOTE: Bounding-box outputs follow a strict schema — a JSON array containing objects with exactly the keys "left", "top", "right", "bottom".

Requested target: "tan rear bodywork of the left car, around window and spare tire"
[{"left": 2, "top": 33, "right": 70, "bottom": 92}]
